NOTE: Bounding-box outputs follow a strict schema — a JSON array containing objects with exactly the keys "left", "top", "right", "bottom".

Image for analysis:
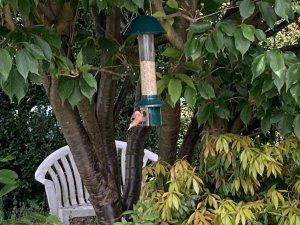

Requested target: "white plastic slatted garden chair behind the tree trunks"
[{"left": 35, "top": 141, "right": 158, "bottom": 225}]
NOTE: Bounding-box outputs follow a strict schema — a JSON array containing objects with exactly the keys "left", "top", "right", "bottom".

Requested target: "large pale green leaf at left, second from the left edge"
[{"left": 16, "top": 48, "right": 39, "bottom": 80}]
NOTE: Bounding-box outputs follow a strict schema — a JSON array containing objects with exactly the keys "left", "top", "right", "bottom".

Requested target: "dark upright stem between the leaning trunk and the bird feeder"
[{"left": 95, "top": 9, "right": 121, "bottom": 189}]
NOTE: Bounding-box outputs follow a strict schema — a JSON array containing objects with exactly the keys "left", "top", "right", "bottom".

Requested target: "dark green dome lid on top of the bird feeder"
[{"left": 123, "top": 16, "right": 165, "bottom": 36}]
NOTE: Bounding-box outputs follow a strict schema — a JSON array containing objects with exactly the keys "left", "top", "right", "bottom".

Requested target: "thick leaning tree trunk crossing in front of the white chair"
[{"left": 43, "top": 75, "right": 122, "bottom": 224}]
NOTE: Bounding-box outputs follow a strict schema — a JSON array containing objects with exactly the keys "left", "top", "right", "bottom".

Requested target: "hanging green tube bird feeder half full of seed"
[{"left": 124, "top": 16, "right": 165, "bottom": 126}]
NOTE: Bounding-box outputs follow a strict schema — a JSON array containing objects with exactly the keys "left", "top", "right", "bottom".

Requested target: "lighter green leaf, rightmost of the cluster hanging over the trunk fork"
[{"left": 79, "top": 74, "right": 97, "bottom": 102}]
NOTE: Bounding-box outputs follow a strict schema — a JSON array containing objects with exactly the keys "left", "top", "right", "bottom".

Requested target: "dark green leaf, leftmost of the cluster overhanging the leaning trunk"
[{"left": 58, "top": 76, "right": 75, "bottom": 103}]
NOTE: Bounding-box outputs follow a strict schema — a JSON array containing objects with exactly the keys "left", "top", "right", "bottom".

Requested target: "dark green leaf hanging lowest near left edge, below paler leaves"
[{"left": 2, "top": 68, "right": 28, "bottom": 102}]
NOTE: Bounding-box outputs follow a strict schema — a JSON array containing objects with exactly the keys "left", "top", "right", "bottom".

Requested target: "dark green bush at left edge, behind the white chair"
[{"left": 0, "top": 85, "right": 65, "bottom": 218}]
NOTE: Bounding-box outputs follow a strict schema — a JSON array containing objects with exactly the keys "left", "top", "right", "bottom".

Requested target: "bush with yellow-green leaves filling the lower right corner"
[{"left": 117, "top": 134, "right": 300, "bottom": 225}]
